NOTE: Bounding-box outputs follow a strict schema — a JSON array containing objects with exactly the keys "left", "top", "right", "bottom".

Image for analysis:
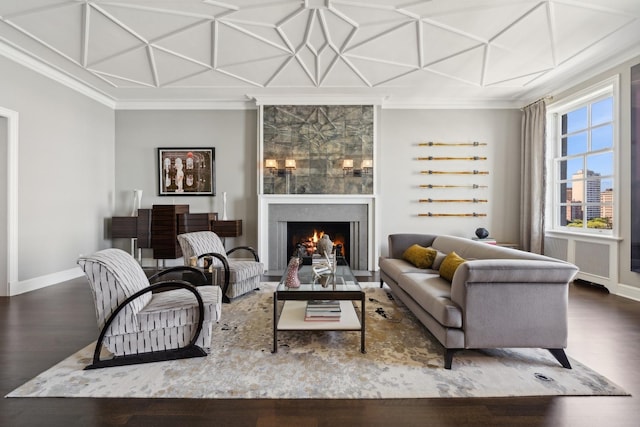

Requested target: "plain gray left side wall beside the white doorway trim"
[{"left": 0, "top": 57, "right": 114, "bottom": 286}]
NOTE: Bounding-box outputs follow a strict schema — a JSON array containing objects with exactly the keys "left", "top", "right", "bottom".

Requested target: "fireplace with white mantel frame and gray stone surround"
[{"left": 260, "top": 201, "right": 371, "bottom": 271}]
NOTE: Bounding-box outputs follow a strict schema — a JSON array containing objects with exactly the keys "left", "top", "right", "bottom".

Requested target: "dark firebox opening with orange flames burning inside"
[{"left": 287, "top": 221, "right": 351, "bottom": 264}]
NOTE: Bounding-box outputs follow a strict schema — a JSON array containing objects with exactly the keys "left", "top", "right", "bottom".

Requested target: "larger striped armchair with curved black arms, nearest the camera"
[{"left": 78, "top": 249, "right": 222, "bottom": 369}]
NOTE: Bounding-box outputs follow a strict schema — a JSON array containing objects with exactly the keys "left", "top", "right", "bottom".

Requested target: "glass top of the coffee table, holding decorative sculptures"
[{"left": 276, "top": 265, "right": 362, "bottom": 292}]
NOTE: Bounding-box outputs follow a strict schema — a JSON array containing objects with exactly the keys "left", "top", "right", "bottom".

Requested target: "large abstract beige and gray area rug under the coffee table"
[{"left": 7, "top": 283, "right": 627, "bottom": 399}]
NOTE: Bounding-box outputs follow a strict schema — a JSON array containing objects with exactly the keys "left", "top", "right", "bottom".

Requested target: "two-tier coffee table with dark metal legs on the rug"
[{"left": 273, "top": 265, "right": 366, "bottom": 353}]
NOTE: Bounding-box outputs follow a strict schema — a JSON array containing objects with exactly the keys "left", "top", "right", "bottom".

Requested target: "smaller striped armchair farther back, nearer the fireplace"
[{"left": 178, "top": 231, "right": 264, "bottom": 302}]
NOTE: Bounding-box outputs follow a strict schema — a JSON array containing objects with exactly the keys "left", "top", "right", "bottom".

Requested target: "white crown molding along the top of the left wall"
[{"left": 0, "top": 40, "right": 116, "bottom": 109}]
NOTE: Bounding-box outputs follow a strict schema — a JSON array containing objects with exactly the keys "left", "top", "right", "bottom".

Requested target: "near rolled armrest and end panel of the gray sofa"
[{"left": 451, "top": 259, "right": 578, "bottom": 348}]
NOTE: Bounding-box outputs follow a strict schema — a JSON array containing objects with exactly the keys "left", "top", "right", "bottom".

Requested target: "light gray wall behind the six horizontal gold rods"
[{"left": 377, "top": 110, "right": 521, "bottom": 255}]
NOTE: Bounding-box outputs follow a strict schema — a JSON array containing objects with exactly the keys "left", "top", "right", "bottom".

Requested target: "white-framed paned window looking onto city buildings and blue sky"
[{"left": 548, "top": 79, "right": 618, "bottom": 234}]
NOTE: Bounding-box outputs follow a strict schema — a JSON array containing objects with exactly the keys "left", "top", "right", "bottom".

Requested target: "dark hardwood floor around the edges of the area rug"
[{"left": 0, "top": 276, "right": 640, "bottom": 427}]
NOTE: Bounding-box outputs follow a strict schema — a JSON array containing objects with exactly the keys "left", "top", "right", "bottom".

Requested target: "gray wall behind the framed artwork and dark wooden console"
[{"left": 114, "top": 110, "right": 258, "bottom": 264}]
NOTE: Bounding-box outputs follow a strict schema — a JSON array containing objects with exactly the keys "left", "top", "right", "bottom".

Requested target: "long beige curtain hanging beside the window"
[{"left": 520, "top": 100, "right": 547, "bottom": 254}]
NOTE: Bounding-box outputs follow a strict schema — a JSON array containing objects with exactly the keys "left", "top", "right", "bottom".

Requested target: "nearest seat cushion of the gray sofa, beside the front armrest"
[{"left": 398, "top": 270, "right": 462, "bottom": 328}]
